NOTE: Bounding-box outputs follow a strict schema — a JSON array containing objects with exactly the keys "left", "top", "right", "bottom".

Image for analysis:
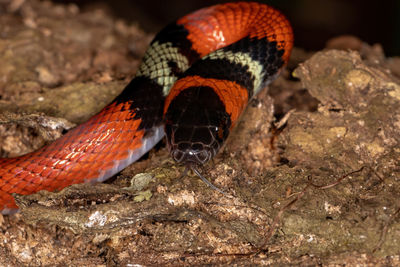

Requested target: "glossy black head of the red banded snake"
[{"left": 165, "top": 87, "right": 231, "bottom": 165}]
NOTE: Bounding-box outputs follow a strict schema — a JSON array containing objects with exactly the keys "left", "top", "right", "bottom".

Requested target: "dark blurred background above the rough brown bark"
[{"left": 54, "top": 0, "right": 400, "bottom": 56}]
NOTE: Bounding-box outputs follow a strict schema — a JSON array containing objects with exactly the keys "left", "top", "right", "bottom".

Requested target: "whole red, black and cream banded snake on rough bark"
[{"left": 0, "top": 2, "right": 293, "bottom": 214}]
